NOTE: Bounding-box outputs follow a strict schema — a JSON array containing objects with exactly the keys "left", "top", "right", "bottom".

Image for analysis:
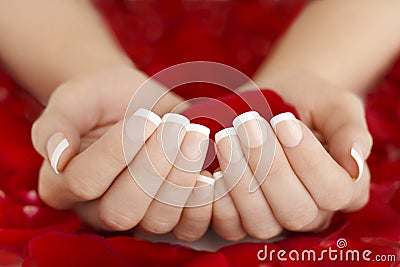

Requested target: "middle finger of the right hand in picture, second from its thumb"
[{"left": 233, "top": 111, "right": 318, "bottom": 231}]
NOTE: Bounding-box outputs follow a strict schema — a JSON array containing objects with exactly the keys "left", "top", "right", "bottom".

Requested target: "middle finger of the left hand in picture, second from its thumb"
[{"left": 99, "top": 114, "right": 189, "bottom": 230}]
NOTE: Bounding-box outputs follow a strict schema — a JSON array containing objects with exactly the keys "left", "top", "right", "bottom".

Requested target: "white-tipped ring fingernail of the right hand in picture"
[{"left": 215, "top": 127, "right": 243, "bottom": 163}]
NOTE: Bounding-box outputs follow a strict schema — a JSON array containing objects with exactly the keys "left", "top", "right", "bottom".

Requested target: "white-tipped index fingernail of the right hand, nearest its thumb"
[{"left": 270, "top": 112, "right": 303, "bottom": 147}]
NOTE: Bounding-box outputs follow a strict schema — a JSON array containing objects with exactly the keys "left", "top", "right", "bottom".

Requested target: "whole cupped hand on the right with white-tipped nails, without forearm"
[{"left": 213, "top": 72, "right": 372, "bottom": 240}]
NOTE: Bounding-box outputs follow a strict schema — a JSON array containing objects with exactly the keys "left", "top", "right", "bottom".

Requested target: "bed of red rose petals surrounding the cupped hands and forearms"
[{"left": 0, "top": 0, "right": 400, "bottom": 266}]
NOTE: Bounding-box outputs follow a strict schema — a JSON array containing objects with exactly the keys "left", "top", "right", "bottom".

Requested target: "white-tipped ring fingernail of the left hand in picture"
[{"left": 181, "top": 123, "right": 210, "bottom": 160}]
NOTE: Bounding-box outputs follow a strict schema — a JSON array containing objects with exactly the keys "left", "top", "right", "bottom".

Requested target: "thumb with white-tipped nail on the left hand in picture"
[{"left": 32, "top": 87, "right": 98, "bottom": 173}]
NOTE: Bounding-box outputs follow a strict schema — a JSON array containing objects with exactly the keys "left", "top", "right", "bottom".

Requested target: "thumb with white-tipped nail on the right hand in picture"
[{"left": 313, "top": 93, "right": 372, "bottom": 179}]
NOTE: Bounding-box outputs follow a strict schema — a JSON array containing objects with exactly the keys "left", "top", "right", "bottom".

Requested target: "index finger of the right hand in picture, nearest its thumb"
[{"left": 271, "top": 113, "right": 354, "bottom": 211}]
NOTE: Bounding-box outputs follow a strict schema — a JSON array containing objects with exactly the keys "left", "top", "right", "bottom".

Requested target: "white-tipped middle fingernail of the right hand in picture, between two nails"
[{"left": 232, "top": 111, "right": 267, "bottom": 148}]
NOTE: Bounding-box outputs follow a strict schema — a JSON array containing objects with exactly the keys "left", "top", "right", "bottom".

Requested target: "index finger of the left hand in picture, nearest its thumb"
[{"left": 39, "top": 109, "right": 161, "bottom": 208}]
